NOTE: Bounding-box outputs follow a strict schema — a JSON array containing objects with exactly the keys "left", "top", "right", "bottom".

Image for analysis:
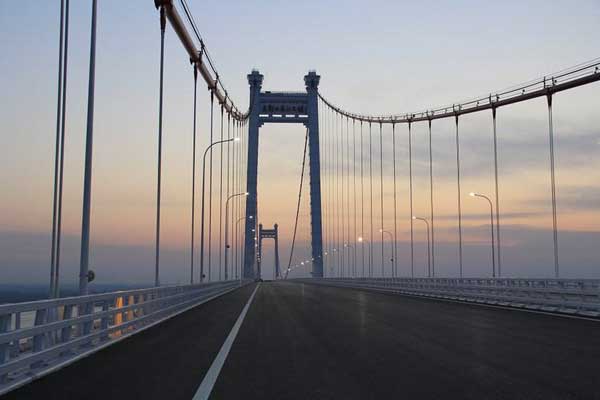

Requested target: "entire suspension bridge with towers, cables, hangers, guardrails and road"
[{"left": 0, "top": 0, "right": 600, "bottom": 399}]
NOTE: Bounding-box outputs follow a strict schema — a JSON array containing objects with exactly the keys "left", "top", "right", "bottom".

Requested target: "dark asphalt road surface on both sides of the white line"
[{"left": 6, "top": 282, "right": 600, "bottom": 400}]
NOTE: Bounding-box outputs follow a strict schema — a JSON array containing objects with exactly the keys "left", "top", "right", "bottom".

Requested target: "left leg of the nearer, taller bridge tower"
[{"left": 243, "top": 70, "right": 263, "bottom": 279}]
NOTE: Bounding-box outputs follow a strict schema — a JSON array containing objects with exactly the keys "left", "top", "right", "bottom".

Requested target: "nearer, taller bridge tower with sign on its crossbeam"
[{"left": 244, "top": 70, "right": 323, "bottom": 279}]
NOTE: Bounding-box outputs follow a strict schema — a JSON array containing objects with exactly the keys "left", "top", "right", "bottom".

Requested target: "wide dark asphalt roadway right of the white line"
[{"left": 211, "top": 282, "right": 600, "bottom": 400}]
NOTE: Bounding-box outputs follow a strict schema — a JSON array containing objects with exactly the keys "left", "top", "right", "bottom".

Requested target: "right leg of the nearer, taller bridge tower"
[{"left": 304, "top": 71, "right": 323, "bottom": 278}]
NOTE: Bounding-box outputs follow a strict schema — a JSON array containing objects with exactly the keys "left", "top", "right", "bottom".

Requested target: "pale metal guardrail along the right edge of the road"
[{"left": 297, "top": 278, "right": 600, "bottom": 317}]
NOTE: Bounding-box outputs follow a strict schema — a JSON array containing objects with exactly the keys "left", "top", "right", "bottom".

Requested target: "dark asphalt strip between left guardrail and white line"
[{"left": 2, "top": 284, "right": 256, "bottom": 400}]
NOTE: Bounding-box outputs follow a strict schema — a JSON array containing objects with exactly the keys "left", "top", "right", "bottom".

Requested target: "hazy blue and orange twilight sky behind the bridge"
[{"left": 0, "top": 0, "right": 600, "bottom": 284}]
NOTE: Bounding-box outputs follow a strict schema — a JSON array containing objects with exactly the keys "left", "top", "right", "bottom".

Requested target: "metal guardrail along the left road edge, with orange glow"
[{"left": 0, "top": 280, "right": 248, "bottom": 395}]
